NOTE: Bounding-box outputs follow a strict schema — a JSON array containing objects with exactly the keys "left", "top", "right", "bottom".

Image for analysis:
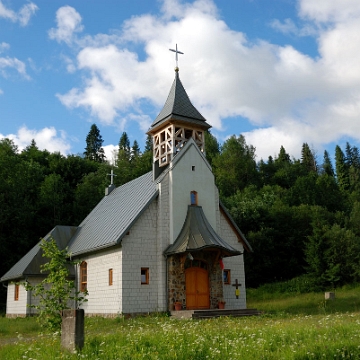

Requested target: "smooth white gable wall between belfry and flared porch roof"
[{"left": 169, "top": 145, "right": 218, "bottom": 243}]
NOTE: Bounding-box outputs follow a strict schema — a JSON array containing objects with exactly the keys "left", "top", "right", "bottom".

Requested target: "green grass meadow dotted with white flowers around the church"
[{"left": 0, "top": 287, "right": 360, "bottom": 360}]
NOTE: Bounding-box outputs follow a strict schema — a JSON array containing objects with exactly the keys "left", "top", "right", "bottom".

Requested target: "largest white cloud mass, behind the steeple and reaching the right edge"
[{"left": 53, "top": 0, "right": 360, "bottom": 158}]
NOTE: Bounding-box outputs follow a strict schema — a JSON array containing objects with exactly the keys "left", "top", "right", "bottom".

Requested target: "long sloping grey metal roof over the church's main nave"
[{"left": 69, "top": 171, "right": 158, "bottom": 255}]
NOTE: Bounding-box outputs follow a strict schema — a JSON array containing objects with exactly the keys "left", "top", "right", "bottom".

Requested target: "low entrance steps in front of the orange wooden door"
[{"left": 170, "top": 309, "right": 261, "bottom": 319}]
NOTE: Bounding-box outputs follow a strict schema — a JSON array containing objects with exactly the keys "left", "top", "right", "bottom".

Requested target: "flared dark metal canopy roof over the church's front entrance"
[{"left": 164, "top": 205, "right": 241, "bottom": 256}]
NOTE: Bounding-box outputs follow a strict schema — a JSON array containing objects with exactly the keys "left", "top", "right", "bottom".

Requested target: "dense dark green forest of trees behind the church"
[{"left": 0, "top": 124, "right": 360, "bottom": 306}]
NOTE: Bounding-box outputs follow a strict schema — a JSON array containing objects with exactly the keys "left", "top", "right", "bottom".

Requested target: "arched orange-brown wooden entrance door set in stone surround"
[{"left": 185, "top": 267, "right": 210, "bottom": 310}]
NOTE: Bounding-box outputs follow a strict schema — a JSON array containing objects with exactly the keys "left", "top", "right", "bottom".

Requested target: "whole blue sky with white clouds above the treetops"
[{"left": 0, "top": 0, "right": 360, "bottom": 162}]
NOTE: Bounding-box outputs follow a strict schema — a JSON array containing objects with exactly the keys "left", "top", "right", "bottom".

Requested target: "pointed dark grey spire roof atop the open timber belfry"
[{"left": 150, "top": 71, "right": 211, "bottom": 129}]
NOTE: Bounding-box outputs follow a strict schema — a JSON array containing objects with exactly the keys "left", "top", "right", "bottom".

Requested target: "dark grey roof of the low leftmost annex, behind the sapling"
[{"left": 0, "top": 225, "right": 77, "bottom": 281}]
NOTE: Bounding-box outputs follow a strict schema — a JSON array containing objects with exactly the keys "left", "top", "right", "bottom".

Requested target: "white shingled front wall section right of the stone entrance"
[{"left": 220, "top": 212, "right": 246, "bottom": 309}]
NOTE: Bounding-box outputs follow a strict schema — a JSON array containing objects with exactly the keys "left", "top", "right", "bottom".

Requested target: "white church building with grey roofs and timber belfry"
[{"left": 0, "top": 67, "right": 252, "bottom": 317}]
